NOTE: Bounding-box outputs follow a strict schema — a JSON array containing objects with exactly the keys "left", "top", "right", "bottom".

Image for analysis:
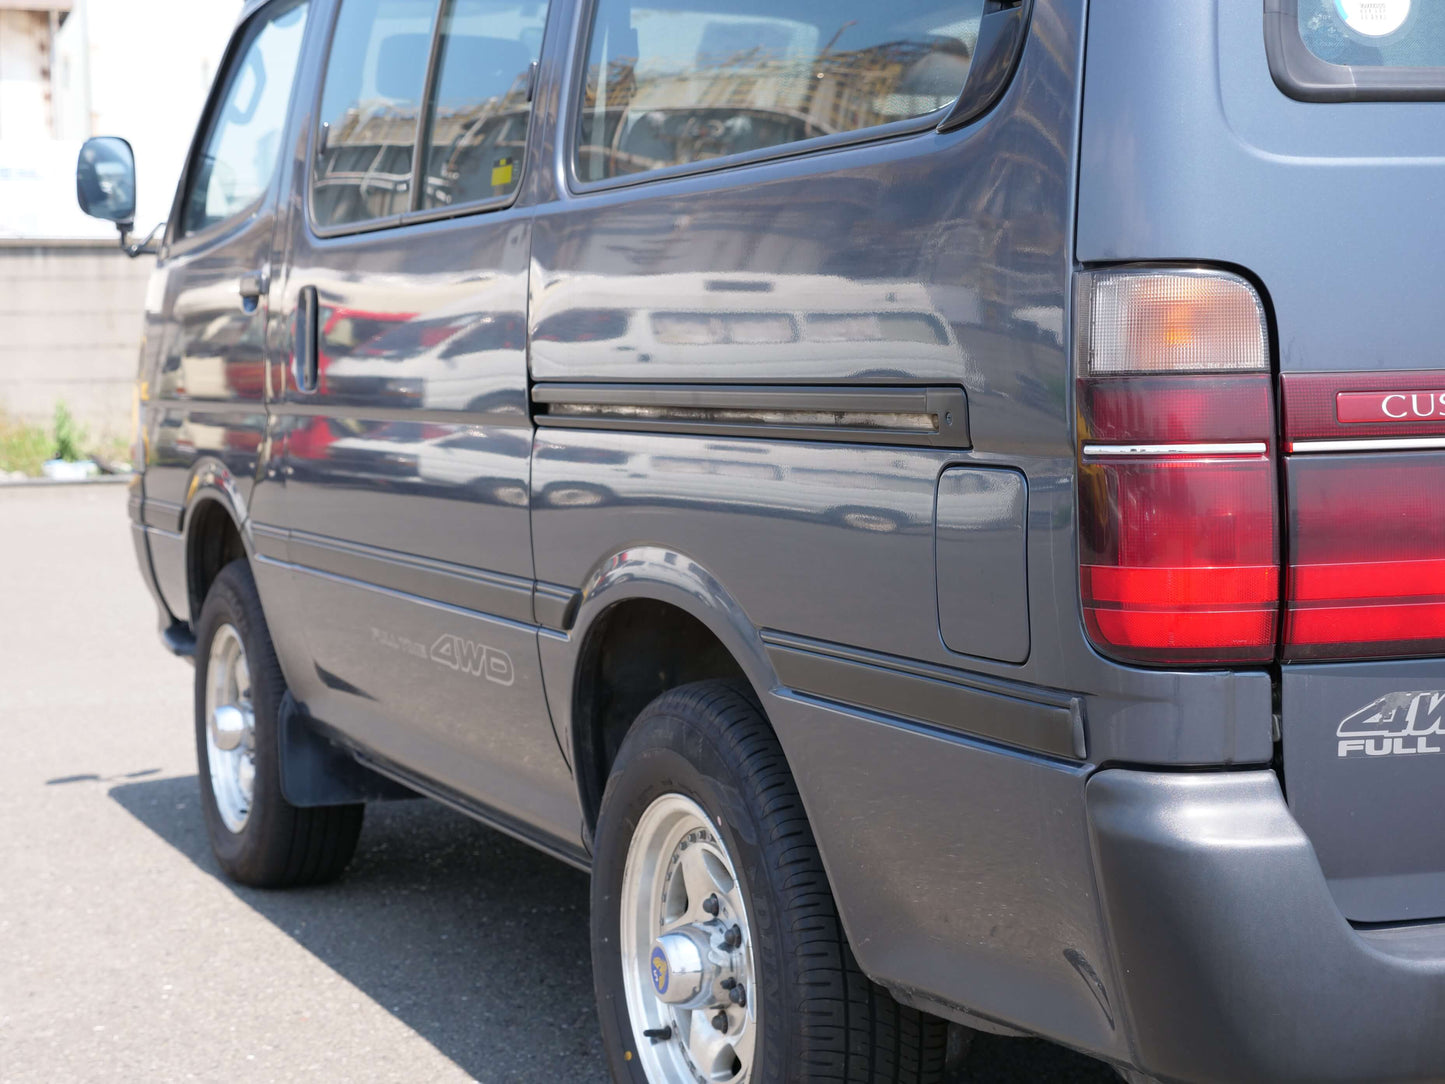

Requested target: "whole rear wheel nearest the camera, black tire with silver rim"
[{"left": 592, "top": 681, "right": 946, "bottom": 1084}]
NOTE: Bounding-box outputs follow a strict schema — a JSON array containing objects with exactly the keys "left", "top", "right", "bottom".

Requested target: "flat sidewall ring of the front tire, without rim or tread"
[{"left": 195, "top": 561, "right": 288, "bottom": 880}]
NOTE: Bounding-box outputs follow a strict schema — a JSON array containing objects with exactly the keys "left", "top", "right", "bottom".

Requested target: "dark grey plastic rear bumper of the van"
[{"left": 1085, "top": 770, "right": 1445, "bottom": 1081}]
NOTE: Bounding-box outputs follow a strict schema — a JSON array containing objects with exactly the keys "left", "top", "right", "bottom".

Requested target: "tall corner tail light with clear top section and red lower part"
[{"left": 1075, "top": 267, "right": 1280, "bottom": 665}]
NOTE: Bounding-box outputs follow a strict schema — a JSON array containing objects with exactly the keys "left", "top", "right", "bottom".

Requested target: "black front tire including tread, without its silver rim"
[{"left": 195, "top": 561, "right": 366, "bottom": 887}]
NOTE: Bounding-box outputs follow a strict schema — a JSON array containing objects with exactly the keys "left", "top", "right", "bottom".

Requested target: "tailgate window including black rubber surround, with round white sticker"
[{"left": 1264, "top": 0, "right": 1445, "bottom": 101}]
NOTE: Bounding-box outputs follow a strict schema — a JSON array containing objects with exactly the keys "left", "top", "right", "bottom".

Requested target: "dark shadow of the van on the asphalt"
[{"left": 110, "top": 776, "right": 1118, "bottom": 1084}]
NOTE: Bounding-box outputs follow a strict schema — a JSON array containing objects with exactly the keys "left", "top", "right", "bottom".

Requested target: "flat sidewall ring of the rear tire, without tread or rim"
[{"left": 591, "top": 713, "right": 789, "bottom": 1083}]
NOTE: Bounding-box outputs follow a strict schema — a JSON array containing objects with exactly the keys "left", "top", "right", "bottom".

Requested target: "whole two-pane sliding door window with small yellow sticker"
[{"left": 311, "top": 0, "right": 548, "bottom": 231}]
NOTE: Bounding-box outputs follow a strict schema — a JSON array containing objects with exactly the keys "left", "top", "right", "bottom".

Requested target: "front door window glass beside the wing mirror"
[{"left": 182, "top": 3, "right": 306, "bottom": 234}]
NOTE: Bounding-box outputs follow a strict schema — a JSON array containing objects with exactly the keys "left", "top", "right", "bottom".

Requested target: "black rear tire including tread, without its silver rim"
[{"left": 592, "top": 681, "right": 948, "bottom": 1084}]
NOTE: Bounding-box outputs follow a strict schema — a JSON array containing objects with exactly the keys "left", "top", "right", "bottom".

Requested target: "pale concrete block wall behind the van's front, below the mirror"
[{"left": 0, "top": 240, "right": 155, "bottom": 436}]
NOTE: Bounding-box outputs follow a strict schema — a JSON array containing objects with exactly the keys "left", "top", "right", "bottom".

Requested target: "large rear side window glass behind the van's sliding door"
[{"left": 577, "top": 0, "right": 984, "bottom": 181}]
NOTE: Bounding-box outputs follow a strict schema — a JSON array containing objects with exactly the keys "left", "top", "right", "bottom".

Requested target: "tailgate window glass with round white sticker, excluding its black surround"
[{"left": 1299, "top": 0, "right": 1445, "bottom": 68}]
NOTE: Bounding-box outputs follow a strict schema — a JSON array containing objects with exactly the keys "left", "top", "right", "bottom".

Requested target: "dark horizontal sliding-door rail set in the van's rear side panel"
[{"left": 532, "top": 383, "right": 970, "bottom": 448}]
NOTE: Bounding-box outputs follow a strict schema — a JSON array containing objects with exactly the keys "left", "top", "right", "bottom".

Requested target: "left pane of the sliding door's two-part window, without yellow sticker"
[{"left": 311, "top": 0, "right": 436, "bottom": 227}]
